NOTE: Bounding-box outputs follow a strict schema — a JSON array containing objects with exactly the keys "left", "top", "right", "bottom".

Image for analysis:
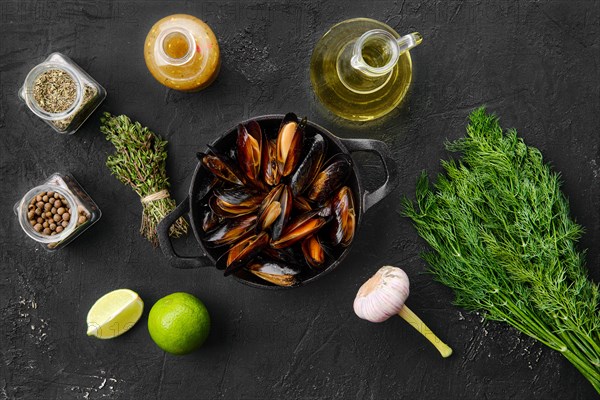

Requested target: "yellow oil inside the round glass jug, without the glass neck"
[{"left": 310, "top": 18, "right": 412, "bottom": 121}]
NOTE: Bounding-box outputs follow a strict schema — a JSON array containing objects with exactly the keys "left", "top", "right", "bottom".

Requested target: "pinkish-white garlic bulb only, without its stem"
[{"left": 354, "top": 265, "right": 410, "bottom": 322}]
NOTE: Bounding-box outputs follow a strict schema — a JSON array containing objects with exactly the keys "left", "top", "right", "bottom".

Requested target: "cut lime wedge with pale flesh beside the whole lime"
[{"left": 87, "top": 289, "right": 144, "bottom": 339}]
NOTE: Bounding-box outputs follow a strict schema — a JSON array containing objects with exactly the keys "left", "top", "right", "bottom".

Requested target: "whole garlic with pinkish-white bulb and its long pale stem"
[{"left": 354, "top": 265, "right": 452, "bottom": 358}]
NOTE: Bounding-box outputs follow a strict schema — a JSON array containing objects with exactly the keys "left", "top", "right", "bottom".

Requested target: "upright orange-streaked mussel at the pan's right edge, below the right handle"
[{"left": 331, "top": 186, "right": 356, "bottom": 247}]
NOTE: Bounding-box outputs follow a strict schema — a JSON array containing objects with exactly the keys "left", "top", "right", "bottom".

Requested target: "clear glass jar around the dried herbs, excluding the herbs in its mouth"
[{"left": 19, "top": 53, "right": 106, "bottom": 134}]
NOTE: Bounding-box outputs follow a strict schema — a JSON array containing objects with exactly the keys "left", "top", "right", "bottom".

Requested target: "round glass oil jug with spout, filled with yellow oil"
[{"left": 310, "top": 18, "right": 422, "bottom": 121}]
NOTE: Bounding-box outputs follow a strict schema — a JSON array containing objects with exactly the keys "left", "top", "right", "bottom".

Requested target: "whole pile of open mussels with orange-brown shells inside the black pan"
[{"left": 198, "top": 113, "right": 356, "bottom": 286}]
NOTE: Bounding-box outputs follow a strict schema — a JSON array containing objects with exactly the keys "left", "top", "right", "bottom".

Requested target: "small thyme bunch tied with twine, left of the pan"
[{"left": 100, "top": 112, "right": 187, "bottom": 246}]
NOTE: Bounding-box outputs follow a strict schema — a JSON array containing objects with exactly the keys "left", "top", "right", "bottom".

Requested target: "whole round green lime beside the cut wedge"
[{"left": 148, "top": 292, "right": 210, "bottom": 354}]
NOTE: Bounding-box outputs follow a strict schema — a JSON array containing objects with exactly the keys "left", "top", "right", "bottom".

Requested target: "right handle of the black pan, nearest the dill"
[{"left": 341, "top": 139, "right": 399, "bottom": 212}]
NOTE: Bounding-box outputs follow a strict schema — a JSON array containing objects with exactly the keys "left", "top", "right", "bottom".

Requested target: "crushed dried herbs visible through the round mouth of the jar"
[{"left": 33, "top": 69, "right": 77, "bottom": 114}]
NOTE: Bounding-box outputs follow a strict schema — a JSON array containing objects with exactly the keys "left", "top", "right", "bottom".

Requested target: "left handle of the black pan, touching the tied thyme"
[{"left": 156, "top": 196, "right": 214, "bottom": 269}]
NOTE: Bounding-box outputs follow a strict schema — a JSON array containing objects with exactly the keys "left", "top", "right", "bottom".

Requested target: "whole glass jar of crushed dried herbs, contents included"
[{"left": 19, "top": 53, "right": 106, "bottom": 134}]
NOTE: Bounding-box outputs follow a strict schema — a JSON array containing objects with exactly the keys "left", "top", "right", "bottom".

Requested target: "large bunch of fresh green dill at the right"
[{"left": 403, "top": 108, "right": 600, "bottom": 393}]
